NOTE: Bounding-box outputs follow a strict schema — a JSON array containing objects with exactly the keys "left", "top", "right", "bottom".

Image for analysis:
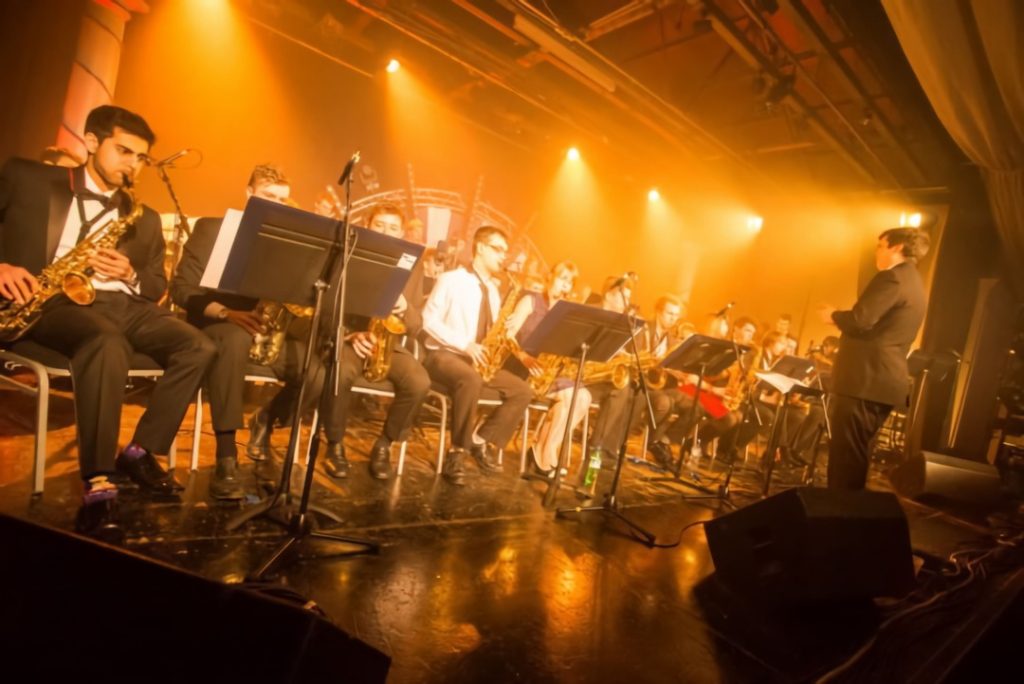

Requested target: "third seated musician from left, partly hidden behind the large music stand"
[{"left": 309, "top": 202, "right": 430, "bottom": 480}]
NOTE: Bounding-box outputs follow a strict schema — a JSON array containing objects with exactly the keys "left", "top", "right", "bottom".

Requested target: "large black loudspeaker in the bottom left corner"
[{"left": 0, "top": 515, "right": 391, "bottom": 683}]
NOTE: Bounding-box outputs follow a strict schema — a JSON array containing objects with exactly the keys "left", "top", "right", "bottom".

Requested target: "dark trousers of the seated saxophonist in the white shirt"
[{"left": 424, "top": 349, "right": 534, "bottom": 448}]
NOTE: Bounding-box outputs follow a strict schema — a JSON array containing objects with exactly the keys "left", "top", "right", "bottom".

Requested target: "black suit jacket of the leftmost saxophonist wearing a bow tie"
[{"left": 0, "top": 158, "right": 167, "bottom": 301}]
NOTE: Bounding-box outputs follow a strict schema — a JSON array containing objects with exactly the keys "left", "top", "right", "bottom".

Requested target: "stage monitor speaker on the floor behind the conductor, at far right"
[{"left": 889, "top": 452, "right": 1002, "bottom": 506}]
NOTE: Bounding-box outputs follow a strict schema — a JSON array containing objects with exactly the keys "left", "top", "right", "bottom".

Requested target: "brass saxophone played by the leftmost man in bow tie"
[{"left": 0, "top": 180, "right": 142, "bottom": 342}]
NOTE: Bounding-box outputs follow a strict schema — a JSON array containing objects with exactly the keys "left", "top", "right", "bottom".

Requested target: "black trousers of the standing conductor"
[{"left": 828, "top": 394, "right": 892, "bottom": 489}]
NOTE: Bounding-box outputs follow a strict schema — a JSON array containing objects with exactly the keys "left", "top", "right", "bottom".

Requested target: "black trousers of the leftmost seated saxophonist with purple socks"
[{"left": 29, "top": 292, "right": 216, "bottom": 479}]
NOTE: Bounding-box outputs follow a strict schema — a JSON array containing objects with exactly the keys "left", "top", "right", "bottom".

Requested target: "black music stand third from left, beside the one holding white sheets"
[{"left": 647, "top": 335, "right": 750, "bottom": 503}]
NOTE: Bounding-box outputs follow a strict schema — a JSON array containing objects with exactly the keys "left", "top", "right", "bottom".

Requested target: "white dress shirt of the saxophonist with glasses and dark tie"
[{"left": 423, "top": 267, "right": 502, "bottom": 351}]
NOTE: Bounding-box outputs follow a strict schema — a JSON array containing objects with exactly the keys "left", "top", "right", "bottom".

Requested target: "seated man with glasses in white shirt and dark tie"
[{"left": 423, "top": 225, "right": 534, "bottom": 485}]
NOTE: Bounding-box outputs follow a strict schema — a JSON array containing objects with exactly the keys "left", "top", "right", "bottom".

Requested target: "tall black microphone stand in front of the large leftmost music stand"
[{"left": 227, "top": 153, "right": 380, "bottom": 580}]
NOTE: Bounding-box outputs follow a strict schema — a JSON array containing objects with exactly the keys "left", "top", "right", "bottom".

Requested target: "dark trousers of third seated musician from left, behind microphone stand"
[{"left": 321, "top": 344, "right": 430, "bottom": 441}]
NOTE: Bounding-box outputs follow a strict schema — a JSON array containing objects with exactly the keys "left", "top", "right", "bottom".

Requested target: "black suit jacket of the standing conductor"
[{"left": 831, "top": 262, "right": 927, "bottom": 407}]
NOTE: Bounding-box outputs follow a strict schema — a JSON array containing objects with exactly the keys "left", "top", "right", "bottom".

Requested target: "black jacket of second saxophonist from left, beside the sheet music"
[{"left": 171, "top": 218, "right": 259, "bottom": 327}]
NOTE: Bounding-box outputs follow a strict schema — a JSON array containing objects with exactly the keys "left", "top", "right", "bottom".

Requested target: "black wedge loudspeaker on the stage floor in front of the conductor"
[{"left": 705, "top": 487, "right": 913, "bottom": 603}]
